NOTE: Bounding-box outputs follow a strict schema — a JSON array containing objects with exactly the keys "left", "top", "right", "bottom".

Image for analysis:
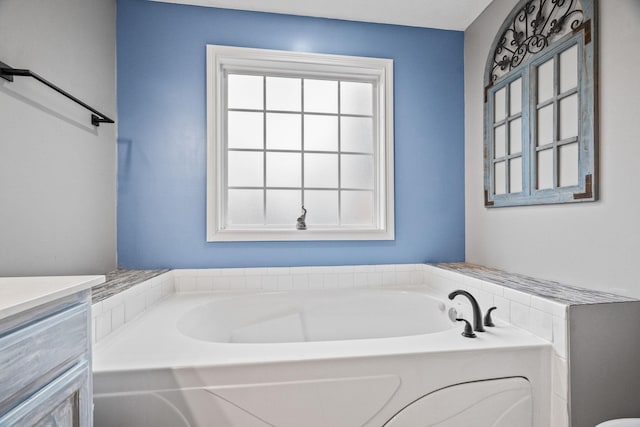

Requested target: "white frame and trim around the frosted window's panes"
[{"left": 207, "top": 45, "right": 395, "bottom": 242}]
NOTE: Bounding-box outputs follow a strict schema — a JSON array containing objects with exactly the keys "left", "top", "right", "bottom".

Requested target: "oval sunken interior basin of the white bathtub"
[{"left": 177, "top": 290, "right": 456, "bottom": 343}]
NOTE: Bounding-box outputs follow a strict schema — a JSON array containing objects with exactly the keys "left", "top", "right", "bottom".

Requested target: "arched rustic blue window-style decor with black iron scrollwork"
[{"left": 484, "top": 0, "right": 596, "bottom": 207}]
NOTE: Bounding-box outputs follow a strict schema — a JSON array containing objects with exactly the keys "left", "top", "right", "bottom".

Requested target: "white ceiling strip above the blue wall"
[{"left": 154, "top": 0, "right": 492, "bottom": 31}]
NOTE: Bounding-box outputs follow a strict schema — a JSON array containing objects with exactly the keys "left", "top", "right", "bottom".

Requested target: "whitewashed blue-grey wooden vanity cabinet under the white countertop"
[{"left": 0, "top": 279, "right": 99, "bottom": 427}]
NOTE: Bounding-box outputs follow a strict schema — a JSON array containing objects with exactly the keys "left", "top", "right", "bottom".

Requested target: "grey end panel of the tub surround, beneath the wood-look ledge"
[{"left": 569, "top": 301, "right": 640, "bottom": 427}]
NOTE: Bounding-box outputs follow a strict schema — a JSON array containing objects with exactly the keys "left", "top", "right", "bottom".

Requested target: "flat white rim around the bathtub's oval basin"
[{"left": 93, "top": 286, "right": 551, "bottom": 373}]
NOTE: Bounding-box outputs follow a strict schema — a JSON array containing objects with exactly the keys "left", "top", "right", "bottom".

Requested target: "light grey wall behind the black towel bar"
[{"left": 0, "top": 0, "right": 116, "bottom": 276}]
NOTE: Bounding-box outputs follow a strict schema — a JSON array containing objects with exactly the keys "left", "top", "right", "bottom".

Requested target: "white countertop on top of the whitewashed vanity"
[{"left": 0, "top": 276, "right": 105, "bottom": 320}]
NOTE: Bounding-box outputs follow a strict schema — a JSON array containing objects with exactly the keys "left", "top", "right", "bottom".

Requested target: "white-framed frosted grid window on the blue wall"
[{"left": 207, "top": 45, "right": 394, "bottom": 241}]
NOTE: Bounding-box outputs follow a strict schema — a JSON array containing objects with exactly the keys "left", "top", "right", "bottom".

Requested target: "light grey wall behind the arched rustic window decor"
[{"left": 465, "top": 0, "right": 640, "bottom": 297}]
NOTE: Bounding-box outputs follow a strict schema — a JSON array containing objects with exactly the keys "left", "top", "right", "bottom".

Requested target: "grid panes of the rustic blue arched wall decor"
[{"left": 491, "top": 45, "right": 580, "bottom": 199}]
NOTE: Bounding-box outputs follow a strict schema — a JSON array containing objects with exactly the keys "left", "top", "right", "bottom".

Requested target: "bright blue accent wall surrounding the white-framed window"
[{"left": 117, "top": 0, "right": 464, "bottom": 269}]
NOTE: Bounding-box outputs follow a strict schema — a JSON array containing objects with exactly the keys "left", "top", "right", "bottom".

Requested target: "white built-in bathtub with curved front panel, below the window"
[{"left": 94, "top": 289, "right": 550, "bottom": 427}]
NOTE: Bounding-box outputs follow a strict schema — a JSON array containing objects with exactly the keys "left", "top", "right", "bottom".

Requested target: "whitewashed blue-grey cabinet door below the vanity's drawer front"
[{"left": 0, "top": 362, "right": 92, "bottom": 427}]
